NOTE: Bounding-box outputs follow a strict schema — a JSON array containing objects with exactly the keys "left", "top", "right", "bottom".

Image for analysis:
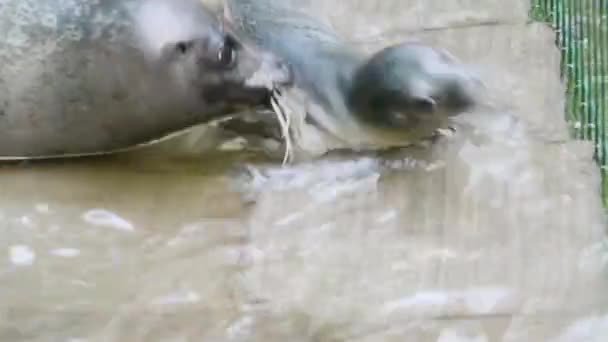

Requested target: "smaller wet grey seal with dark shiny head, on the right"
[{"left": 224, "top": 0, "right": 483, "bottom": 162}]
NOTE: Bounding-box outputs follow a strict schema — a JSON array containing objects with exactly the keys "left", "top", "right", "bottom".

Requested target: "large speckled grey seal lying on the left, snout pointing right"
[{"left": 0, "top": 0, "right": 290, "bottom": 159}]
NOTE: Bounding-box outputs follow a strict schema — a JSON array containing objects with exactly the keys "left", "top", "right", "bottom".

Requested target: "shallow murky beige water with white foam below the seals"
[{"left": 0, "top": 108, "right": 608, "bottom": 341}]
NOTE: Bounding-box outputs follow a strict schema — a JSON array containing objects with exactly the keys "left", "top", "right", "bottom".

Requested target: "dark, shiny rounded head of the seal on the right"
[{"left": 345, "top": 43, "right": 480, "bottom": 134}]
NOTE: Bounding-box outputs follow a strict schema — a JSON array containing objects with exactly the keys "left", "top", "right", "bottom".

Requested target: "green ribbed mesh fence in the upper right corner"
[{"left": 532, "top": 0, "right": 608, "bottom": 205}]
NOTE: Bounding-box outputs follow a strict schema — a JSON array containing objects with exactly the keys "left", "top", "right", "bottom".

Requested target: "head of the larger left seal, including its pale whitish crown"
[{"left": 134, "top": 0, "right": 291, "bottom": 111}]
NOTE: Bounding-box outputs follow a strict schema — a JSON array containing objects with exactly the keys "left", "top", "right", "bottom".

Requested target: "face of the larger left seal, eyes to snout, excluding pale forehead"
[{"left": 159, "top": 29, "right": 290, "bottom": 116}]
